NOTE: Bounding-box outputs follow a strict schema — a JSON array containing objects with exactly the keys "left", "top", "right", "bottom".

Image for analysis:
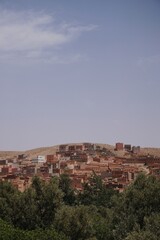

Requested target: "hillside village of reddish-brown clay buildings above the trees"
[{"left": 0, "top": 143, "right": 160, "bottom": 192}]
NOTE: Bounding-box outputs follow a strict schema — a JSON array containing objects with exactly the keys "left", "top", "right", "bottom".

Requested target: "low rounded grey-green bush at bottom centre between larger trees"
[{"left": 54, "top": 206, "right": 95, "bottom": 240}]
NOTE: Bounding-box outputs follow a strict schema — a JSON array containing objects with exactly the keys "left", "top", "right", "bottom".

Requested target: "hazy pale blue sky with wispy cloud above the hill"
[{"left": 0, "top": 0, "right": 160, "bottom": 150}]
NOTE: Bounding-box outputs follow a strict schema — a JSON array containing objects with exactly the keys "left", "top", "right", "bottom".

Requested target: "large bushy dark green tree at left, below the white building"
[{"left": 12, "top": 177, "right": 63, "bottom": 230}]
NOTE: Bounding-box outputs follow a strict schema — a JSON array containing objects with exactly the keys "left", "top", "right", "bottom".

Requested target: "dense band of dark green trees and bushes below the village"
[{"left": 0, "top": 174, "right": 160, "bottom": 240}]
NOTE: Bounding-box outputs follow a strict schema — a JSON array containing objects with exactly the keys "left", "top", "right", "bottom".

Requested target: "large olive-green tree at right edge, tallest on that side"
[{"left": 112, "top": 174, "right": 160, "bottom": 239}]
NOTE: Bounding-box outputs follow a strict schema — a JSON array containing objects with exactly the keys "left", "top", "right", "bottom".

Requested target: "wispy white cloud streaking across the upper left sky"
[{"left": 0, "top": 9, "right": 96, "bottom": 60}]
